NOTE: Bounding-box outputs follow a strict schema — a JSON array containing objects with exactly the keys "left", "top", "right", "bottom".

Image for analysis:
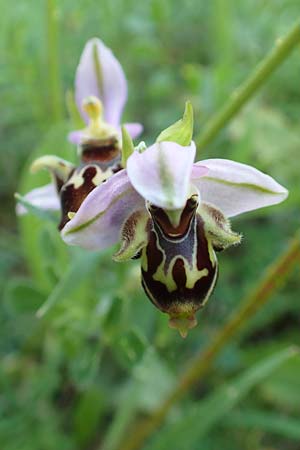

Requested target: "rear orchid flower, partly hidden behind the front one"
[{"left": 17, "top": 38, "right": 143, "bottom": 229}]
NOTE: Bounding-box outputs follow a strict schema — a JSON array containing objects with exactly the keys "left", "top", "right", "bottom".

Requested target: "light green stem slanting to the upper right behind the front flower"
[{"left": 195, "top": 22, "right": 300, "bottom": 151}]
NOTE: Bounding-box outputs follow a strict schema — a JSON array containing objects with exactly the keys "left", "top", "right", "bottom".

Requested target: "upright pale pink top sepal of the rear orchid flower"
[{"left": 75, "top": 38, "right": 127, "bottom": 126}]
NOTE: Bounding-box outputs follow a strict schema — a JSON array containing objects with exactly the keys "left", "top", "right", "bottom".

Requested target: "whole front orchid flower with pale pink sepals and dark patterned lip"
[{"left": 53, "top": 104, "right": 288, "bottom": 336}]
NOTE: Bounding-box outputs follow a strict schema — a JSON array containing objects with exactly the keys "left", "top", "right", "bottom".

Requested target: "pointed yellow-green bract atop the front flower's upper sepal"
[{"left": 156, "top": 102, "right": 194, "bottom": 146}]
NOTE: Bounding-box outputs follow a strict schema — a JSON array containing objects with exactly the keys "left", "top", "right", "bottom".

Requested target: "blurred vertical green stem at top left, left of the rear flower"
[{"left": 46, "top": 0, "right": 63, "bottom": 122}]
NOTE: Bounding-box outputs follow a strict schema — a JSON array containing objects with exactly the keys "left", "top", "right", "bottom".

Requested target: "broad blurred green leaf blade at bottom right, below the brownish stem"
[{"left": 146, "top": 348, "right": 299, "bottom": 450}]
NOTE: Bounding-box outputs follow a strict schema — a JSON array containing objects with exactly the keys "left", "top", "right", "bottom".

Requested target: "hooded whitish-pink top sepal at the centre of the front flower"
[{"left": 127, "top": 142, "right": 196, "bottom": 209}]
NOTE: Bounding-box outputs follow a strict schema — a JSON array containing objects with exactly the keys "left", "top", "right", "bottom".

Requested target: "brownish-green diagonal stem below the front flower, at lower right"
[{"left": 122, "top": 230, "right": 300, "bottom": 450}]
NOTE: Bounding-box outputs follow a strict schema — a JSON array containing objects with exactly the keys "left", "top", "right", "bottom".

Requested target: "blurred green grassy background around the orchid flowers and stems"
[{"left": 0, "top": 0, "right": 300, "bottom": 450}]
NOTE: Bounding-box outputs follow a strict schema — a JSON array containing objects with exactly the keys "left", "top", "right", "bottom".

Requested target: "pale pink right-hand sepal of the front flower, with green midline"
[{"left": 192, "top": 159, "right": 288, "bottom": 217}]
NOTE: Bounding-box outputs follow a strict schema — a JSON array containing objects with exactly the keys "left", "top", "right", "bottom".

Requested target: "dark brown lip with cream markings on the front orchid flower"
[{"left": 142, "top": 198, "right": 217, "bottom": 328}]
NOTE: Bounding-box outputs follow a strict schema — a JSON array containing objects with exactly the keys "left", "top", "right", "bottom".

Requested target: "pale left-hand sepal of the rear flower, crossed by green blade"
[{"left": 16, "top": 183, "right": 60, "bottom": 215}]
